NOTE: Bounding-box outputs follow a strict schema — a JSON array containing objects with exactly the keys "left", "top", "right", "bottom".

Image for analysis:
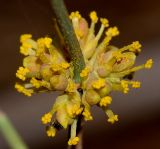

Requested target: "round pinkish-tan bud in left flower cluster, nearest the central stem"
[{"left": 50, "top": 75, "right": 68, "bottom": 91}]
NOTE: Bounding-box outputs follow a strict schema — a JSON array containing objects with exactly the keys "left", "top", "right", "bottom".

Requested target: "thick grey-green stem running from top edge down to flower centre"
[{"left": 51, "top": 0, "right": 85, "bottom": 83}]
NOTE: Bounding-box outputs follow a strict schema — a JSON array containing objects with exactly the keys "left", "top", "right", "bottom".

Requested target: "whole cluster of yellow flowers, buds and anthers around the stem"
[{"left": 15, "top": 11, "right": 153, "bottom": 145}]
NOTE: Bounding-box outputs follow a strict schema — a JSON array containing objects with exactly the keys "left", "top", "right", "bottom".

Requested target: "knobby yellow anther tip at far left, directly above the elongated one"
[{"left": 16, "top": 67, "right": 29, "bottom": 81}]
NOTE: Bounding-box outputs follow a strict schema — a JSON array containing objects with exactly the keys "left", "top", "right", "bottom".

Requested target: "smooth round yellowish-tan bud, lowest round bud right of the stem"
[{"left": 85, "top": 89, "right": 100, "bottom": 105}]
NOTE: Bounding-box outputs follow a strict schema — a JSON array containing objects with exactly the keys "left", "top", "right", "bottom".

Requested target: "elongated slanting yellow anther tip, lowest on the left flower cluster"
[{"left": 15, "top": 83, "right": 34, "bottom": 97}]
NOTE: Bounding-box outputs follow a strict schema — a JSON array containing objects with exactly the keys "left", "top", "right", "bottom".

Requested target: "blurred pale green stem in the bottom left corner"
[{"left": 0, "top": 111, "right": 28, "bottom": 149}]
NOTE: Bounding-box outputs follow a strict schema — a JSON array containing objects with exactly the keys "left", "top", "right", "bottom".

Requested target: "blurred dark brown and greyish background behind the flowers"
[{"left": 0, "top": 0, "right": 160, "bottom": 149}]
